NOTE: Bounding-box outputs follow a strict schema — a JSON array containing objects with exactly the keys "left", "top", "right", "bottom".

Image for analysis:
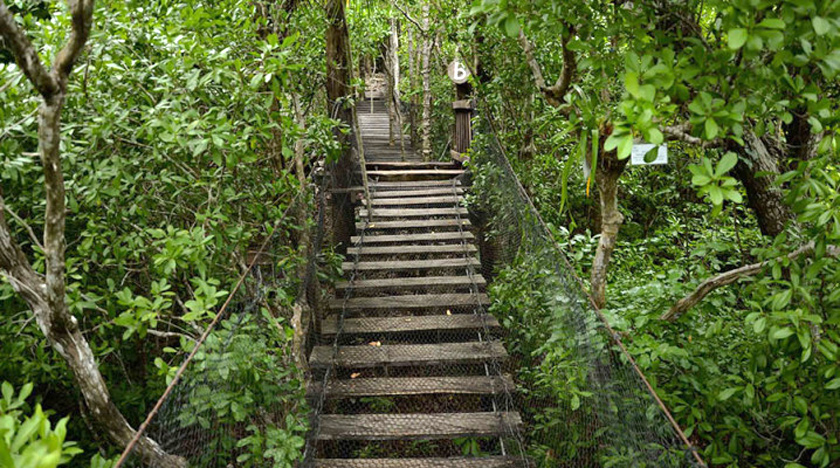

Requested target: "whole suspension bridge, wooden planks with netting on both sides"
[{"left": 115, "top": 95, "right": 705, "bottom": 468}]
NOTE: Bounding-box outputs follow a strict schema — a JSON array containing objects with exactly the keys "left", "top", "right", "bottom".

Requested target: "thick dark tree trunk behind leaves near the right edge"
[{"left": 732, "top": 132, "right": 793, "bottom": 236}]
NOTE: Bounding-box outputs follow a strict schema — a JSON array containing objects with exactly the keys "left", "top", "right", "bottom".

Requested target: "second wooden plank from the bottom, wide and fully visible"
[{"left": 317, "top": 412, "right": 522, "bottom": 440}]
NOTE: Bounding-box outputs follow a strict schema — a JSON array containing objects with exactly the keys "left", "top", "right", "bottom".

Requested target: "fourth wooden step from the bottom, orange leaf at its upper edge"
[{"left": 309, "top": 341, "right": 507, "bottom": 369}]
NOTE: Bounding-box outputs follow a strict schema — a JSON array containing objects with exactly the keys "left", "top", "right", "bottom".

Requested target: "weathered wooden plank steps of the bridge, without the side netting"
[{"left": 309, "top": 101, "right": 527, "bottom": 468}]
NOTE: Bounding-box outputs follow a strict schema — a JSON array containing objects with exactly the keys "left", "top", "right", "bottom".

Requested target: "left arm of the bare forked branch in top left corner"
[{"left": 0, "top": 0, "right": 59, "bottom": 97}]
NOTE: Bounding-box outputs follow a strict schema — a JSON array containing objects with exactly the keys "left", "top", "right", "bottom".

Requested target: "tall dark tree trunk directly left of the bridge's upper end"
[{"left": 326, "top": 0, "right": 355, "bottom": 251}]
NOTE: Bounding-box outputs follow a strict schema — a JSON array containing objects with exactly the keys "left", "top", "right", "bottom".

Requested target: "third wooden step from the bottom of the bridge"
[{"left": 308, "top": 375, "right": 516, "bottom": 398}]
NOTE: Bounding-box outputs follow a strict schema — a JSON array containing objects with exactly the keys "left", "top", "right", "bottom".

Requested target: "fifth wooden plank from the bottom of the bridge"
[{"left": 321, "top": 314, "right": 501, "bottom": 335}]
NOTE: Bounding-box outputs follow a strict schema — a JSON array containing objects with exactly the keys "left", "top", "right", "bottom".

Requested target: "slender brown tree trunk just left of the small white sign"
[{"left": 590, "top": 150, "right": 628, "bottom": 307}]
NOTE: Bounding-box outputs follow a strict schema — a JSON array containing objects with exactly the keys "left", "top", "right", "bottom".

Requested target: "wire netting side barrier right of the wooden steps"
[{"left": 470, "top": 110, "right": 706, "bottom": 467}]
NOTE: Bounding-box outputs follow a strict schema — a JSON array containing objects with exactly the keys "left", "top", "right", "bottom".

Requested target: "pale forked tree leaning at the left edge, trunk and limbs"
[{"left": 0, "top": 0, "right": 184, "bottom": 467}]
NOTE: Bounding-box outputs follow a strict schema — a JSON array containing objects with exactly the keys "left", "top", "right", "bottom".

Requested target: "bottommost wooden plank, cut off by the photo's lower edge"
[{"left": 315, "top": 456, "right": 533, "bottom": 468}]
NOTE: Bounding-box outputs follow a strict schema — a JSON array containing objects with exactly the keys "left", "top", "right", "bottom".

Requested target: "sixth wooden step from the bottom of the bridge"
[{"left": 329, "top": 293, "right": 490, "bottom": 310}]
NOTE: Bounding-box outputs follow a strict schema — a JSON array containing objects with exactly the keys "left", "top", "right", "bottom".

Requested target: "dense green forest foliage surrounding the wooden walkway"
[{"left": 0, "top": 0, "right": 840, "bottom": 468}]
